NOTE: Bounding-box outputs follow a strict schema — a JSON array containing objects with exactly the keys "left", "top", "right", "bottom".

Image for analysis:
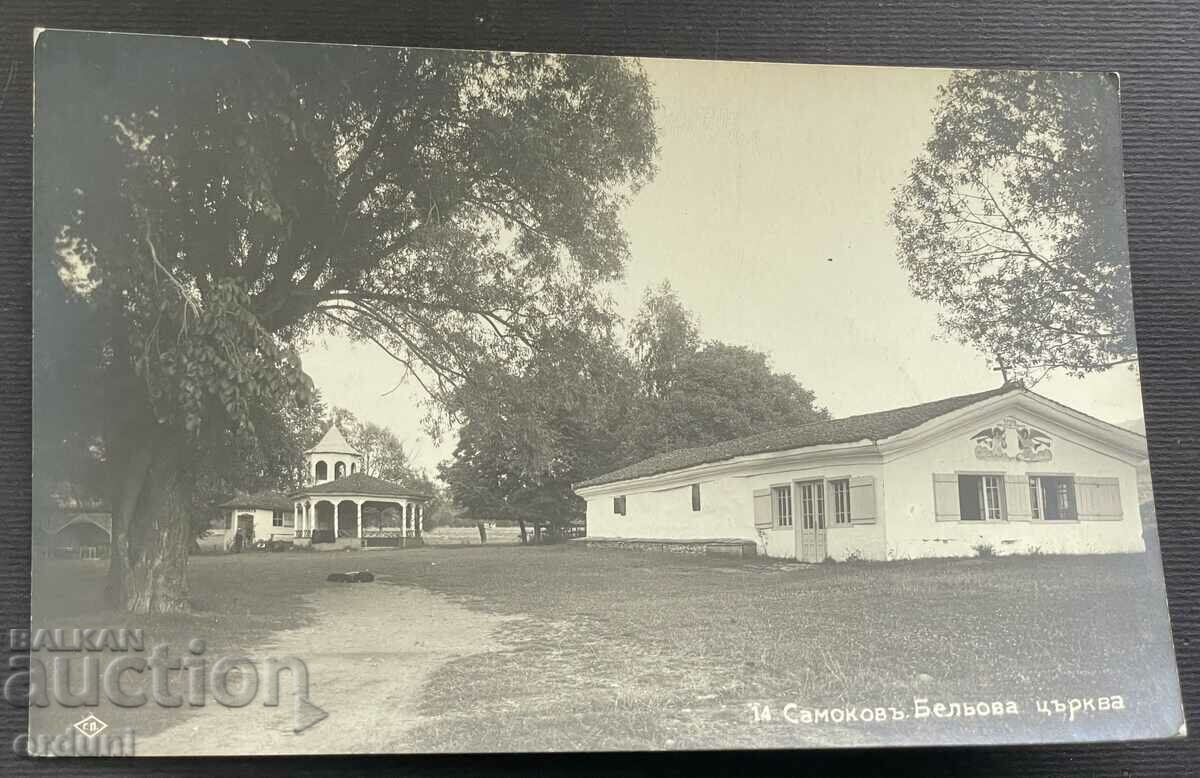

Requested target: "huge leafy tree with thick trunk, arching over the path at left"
[{"left": 35, "top": 31, "right": 655, "bottom": 612}]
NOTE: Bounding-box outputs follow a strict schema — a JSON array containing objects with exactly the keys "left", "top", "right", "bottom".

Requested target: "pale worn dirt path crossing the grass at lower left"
[{"left": 136, "top": 582, "right": 505, "bottom": 755}]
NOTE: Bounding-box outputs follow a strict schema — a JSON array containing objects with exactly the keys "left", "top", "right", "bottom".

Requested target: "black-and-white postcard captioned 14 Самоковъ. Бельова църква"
[{"left": 25, "top": 30, "right": 1186, "bottom": 756}]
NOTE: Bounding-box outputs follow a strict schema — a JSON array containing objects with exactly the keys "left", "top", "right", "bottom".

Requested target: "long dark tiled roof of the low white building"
[{"left": 576, "top": 385, "right": 1016, "bottom": 487}]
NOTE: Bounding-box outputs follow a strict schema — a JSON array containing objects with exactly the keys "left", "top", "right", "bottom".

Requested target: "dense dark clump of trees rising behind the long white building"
[{"left": 440, "top": 282, "right": 828, "bottom": 537}]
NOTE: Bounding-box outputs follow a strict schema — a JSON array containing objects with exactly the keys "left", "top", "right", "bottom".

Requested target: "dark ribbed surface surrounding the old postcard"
[{"left": 0, "top": 0, "right": 1200, "bottom": 777}]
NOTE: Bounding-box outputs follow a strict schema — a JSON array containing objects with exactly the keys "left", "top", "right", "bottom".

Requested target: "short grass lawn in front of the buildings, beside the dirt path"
[{"left": 34, "top": 545, "right": 1175, "bottom": 750}]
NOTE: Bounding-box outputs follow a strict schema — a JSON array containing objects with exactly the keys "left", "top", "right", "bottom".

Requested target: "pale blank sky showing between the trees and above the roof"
[{"left": 304, "top": 59, "right": 1142, "bottom": 475}]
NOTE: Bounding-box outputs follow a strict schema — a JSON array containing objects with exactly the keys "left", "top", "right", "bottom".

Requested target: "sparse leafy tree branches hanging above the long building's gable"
[{"left": 892, "top": 71, "right": 1136, "bottom": 379}]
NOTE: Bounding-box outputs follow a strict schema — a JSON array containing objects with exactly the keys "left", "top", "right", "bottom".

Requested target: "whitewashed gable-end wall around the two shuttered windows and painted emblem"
[{"left": 883, "top": 411, "right": 1145, "bottom": 559}]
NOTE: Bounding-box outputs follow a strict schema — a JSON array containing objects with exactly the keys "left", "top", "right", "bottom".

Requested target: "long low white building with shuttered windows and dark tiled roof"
[{"left": 575, "top": 384, "right": 1146, "bottom": 562}]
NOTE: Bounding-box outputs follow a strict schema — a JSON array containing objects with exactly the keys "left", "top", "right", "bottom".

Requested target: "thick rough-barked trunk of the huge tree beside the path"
[{"left": 108, "top": 424, "right": 192, "bottom": 614}]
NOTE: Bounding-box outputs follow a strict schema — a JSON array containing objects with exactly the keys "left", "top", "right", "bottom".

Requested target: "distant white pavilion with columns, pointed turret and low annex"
[{"left": 221, "top": 424, "right": 432, "bottom": 549}]
